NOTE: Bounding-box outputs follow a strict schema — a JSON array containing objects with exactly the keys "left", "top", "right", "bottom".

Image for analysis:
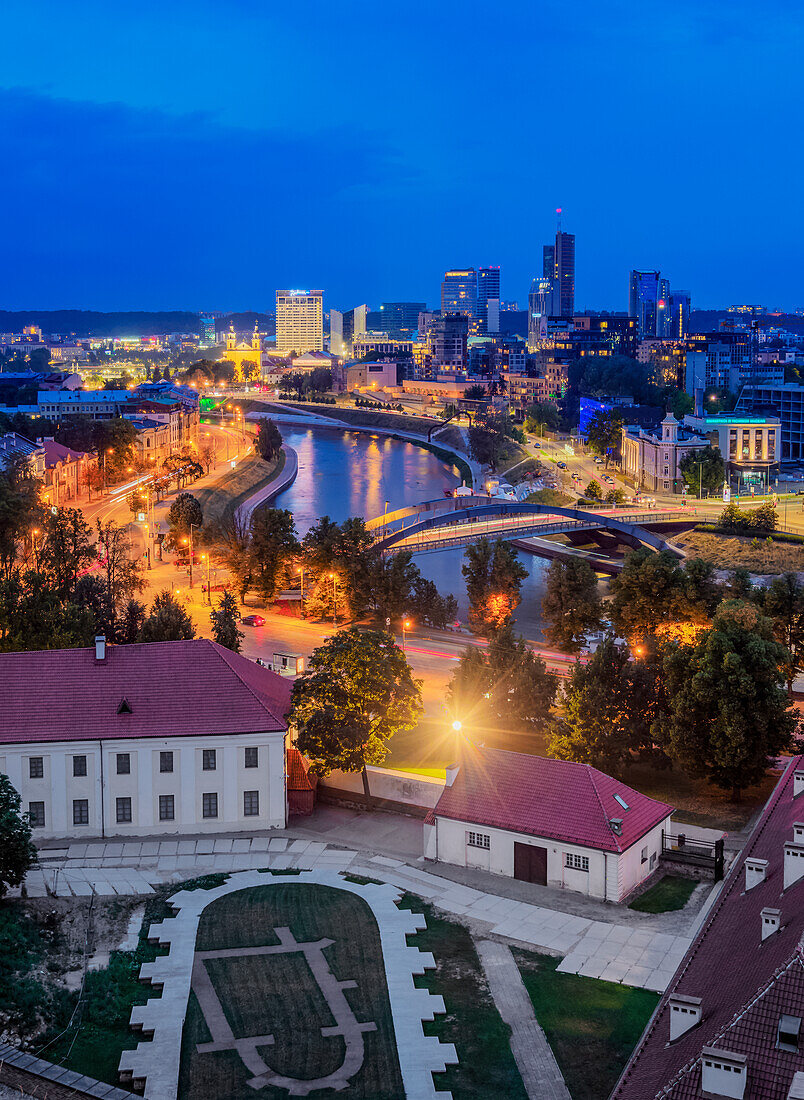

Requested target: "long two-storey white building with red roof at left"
[{"left": 0, "top": 638, "right": 290, "bottom": 839}]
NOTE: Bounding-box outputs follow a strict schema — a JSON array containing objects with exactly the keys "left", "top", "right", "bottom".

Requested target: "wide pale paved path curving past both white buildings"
[{"left": 29, "top": 835, "right": 692, "bottom": 992}]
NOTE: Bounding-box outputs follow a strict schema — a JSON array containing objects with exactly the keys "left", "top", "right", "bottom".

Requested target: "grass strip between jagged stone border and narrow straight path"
[{"left": 399, "top": 894, "right": 527, "bottom": 1100}]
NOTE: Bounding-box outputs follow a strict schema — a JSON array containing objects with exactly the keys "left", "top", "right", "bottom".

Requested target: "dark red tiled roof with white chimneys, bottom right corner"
[{"left": 612, "top": 757, "right": 804, "bottom": 1100}]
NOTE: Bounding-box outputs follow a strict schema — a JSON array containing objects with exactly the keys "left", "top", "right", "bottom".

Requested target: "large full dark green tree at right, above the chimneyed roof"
[{"left": 657, "top": 601, "right": 796, "bottom": 800}]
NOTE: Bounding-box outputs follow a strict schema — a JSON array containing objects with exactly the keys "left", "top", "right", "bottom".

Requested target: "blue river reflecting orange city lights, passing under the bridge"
[{"left": 276, "top": 425, "right": 548, "bottom": 640}]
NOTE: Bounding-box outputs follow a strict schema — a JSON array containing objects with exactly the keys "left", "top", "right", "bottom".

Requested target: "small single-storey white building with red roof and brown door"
[{"left": 425, "top": 744, "right": 673, "bottom": 902}]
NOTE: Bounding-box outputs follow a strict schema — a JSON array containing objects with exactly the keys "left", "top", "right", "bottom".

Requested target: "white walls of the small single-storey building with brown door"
[{"left": 425, "top": 815, "right": 670, "bottom": 902}]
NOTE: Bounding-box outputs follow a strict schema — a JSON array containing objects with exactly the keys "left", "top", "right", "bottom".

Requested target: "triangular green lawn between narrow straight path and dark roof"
[{"left": 514, "top": 948, "right": 659, "bottom": 1100}]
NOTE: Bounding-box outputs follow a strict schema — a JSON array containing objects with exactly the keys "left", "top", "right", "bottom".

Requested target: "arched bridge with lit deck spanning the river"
[{"left": 366, "top": 496, "right": 691, "bottom": 558}]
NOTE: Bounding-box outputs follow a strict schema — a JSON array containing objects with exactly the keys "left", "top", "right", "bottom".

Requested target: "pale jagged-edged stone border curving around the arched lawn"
[{"left": 120, "top": 869, "right": 458, "bottom": 1100}]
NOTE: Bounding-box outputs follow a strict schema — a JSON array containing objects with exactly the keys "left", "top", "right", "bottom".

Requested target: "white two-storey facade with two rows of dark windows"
[{"left": 0, "top": 730, "right": 286, "bottom": 840}]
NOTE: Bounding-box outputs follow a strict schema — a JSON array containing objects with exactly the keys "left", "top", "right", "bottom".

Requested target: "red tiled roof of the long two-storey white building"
[{"left": 0, "top": 638, "right": 290, "bottom": 744}]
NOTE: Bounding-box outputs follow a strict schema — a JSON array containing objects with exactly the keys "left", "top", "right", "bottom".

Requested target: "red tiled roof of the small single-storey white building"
[{"left": 434, "top": 745, "right": 673, "bottom": 851}]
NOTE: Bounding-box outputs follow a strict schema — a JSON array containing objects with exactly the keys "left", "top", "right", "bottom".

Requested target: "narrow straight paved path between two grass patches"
[{"left": 475, "top": 939, "right": 572, "bottom": 1100}]
